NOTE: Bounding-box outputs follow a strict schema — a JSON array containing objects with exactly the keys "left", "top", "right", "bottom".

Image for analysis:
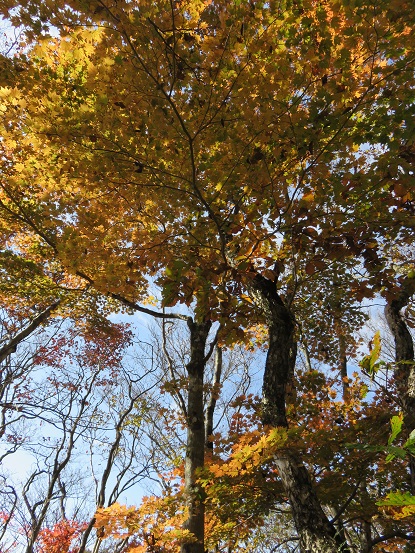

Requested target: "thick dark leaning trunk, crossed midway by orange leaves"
[{"left": 249, "top": 275, "right": 349, "bottom": 553}]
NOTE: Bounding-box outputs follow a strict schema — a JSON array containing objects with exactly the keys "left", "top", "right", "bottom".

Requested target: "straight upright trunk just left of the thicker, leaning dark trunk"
[{"left": 181, "top": 319, "right": 211, "bottom": 553}]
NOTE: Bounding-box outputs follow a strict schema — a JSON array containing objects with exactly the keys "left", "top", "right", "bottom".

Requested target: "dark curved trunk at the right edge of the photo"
[{"left": 385, "top": 286, "right": 415, "bottom": 494}]
